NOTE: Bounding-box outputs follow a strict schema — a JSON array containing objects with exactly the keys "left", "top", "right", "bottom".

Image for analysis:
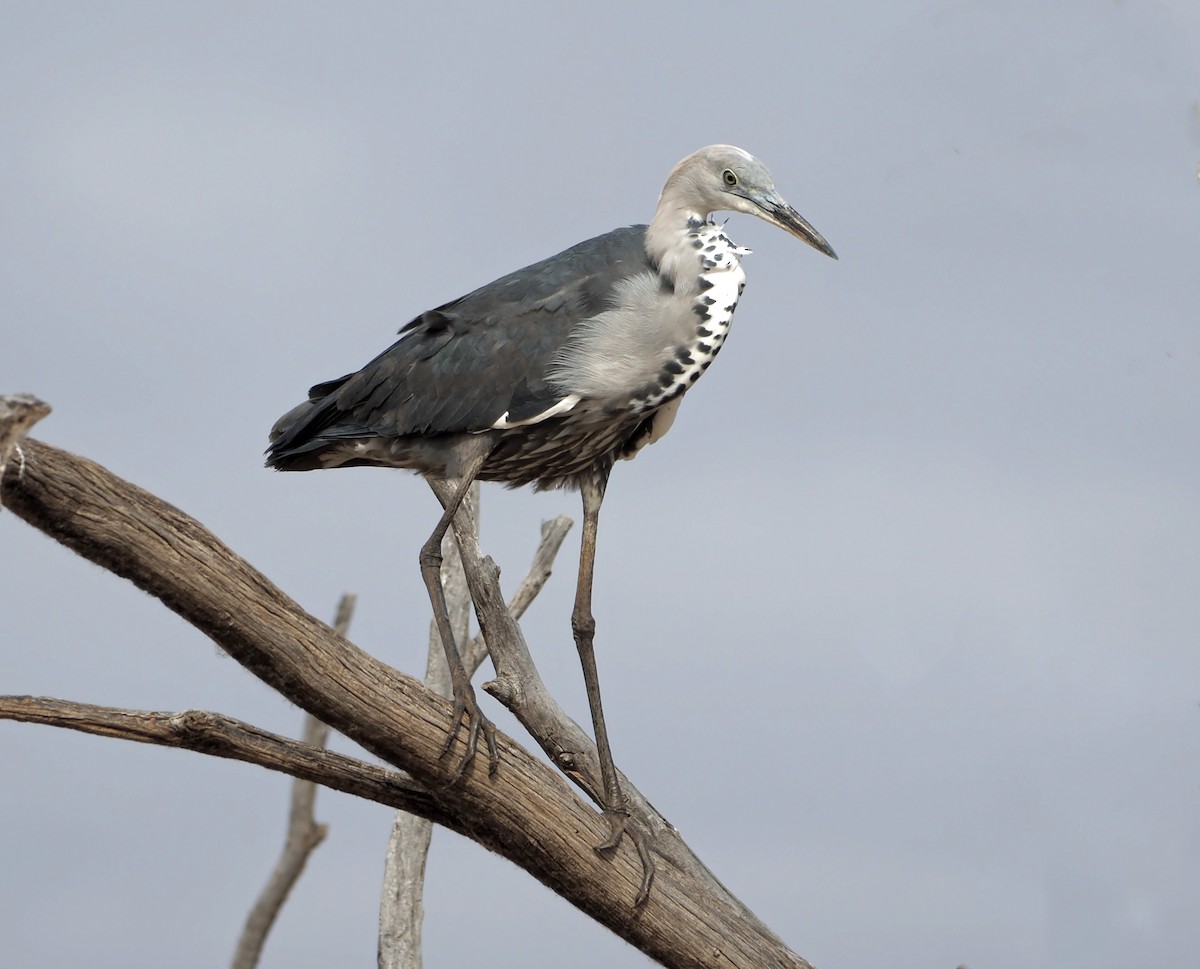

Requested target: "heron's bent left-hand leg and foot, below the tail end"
[{"left": 421, "top": 450, "right": 499, "bottom": 783}]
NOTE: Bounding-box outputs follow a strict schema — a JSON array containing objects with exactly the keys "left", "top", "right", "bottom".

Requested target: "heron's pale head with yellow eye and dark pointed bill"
[{"left": 659, "top": 145, "right": 838, "bottom": 259}]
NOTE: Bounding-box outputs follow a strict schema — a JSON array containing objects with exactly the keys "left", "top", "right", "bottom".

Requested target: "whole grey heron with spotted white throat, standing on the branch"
[{"left": 266, "top": 145, "right": 838, "bottom": 903}]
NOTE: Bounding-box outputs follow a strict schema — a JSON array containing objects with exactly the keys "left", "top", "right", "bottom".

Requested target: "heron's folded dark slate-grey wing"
[{"left": 268, "top": 225, "right": 650, "bottom": 467}]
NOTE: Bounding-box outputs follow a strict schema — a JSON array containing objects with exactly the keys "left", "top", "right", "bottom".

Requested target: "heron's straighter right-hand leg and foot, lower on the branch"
[{"left": 571, "top": 468, "right": 654, "bottom": 908}]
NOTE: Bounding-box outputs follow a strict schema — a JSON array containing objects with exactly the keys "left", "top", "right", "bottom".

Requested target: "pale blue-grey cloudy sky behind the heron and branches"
[{"left": 0, "top": 0, "right": 1200, "bottom": 969}]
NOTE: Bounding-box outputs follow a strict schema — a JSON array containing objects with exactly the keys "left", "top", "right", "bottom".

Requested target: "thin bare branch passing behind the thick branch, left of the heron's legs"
[{"left": 230, "top": 592, "right": 355, "bottom": 969}]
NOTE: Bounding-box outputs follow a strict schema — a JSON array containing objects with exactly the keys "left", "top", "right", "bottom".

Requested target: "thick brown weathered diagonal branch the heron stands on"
[{"left": 0, "top": 440, "right": 808, "bottom": 967}]
